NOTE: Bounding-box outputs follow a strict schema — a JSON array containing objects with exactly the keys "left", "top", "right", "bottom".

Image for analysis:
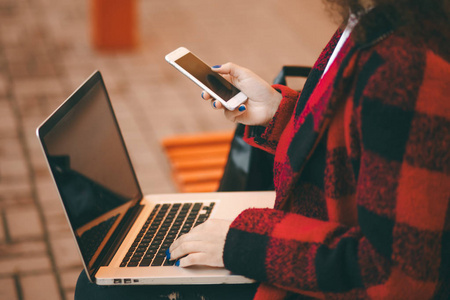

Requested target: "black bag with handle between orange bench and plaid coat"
[{"left": 218, "top": 66, "right": 311, "bottom": 192}]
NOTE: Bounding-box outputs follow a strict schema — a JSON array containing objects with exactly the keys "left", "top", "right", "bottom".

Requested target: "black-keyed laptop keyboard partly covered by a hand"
[{"left": 120, "top": 202, "right": 215, "bottom": 267}]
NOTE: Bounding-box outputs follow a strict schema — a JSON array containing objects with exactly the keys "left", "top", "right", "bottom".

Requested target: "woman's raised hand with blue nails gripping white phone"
[{"left": 202, "top": 63, "right": 282, "bottom": 126}]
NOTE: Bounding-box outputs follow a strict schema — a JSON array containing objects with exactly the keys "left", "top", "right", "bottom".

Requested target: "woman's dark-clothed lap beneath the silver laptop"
[{"left": 75, "top": 271, "right": 258, "bottom": 300}]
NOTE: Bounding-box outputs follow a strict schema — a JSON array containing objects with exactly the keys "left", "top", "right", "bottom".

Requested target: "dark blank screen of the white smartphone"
[{"left": 175, "top": 52, "right": 240, "bottom": 101}]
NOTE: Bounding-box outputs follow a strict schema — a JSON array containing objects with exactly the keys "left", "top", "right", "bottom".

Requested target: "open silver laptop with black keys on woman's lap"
[{"left": 37, "top": 71, "right": 275, "bottom": 285}]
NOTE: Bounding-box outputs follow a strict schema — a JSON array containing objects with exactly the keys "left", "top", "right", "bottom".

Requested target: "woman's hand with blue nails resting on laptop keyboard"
[{"left": 167, "top": 219, "right": 232, "bottom": 267}]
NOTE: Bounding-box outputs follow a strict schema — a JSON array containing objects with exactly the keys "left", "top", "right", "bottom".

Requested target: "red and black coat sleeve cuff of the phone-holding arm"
[{"left": 244, "top": 84, "right": 300, "bottom": 154}]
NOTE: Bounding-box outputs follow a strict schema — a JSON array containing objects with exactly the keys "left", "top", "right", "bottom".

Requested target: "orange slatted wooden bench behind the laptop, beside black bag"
[{"left": 161, "top": 131, "right": 234, "bottom": 193}]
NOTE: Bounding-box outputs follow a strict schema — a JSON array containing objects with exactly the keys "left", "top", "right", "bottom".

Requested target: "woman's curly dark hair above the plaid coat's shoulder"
[{"left": 323, "top": 0, "right": 450, "bottom": 40}]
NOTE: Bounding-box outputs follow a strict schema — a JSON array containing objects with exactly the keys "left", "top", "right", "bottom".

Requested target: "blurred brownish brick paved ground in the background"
[{"left": 0, "top": 0, "right": 334, "bottom": 300}]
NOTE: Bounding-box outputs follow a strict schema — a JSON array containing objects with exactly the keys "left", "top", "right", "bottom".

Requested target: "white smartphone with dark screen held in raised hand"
[{"left": 166, "top": 47, "right": 247, "bottom": 110}]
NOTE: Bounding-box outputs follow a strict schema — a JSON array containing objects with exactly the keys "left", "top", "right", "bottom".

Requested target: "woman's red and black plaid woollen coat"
[{"left": 224, "top": 9, "right": 450, "bottom": 299}]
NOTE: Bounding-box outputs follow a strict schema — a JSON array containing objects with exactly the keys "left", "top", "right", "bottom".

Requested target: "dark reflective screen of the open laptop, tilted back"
[{"left": 38, "top": 72, "right": 142, "bottom": 268}]
